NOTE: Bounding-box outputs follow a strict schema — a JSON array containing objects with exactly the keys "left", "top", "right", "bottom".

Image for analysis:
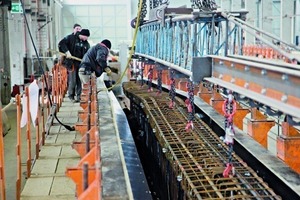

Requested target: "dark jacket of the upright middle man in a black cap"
[{"left": 58, "top": 32, "right": 90, "bottom": 68}]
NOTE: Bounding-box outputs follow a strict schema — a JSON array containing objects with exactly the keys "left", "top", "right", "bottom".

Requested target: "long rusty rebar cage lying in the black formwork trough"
[{"left": 124, "top": 82, "right": 281, "bottom": 199}]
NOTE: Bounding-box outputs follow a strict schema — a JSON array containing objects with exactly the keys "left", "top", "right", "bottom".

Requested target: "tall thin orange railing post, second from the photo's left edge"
[{"left": 16, "top": 94, "right": 22, "bottom": 200}]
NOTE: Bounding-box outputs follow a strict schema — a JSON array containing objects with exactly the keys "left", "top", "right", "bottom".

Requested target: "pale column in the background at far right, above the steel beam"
[{"left": 280, "top": 0, "right": 294, "bottom": 42}]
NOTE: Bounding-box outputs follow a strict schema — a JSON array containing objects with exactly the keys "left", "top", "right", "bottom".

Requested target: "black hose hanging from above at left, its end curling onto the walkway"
[{"left": 20, "top": 0, "right": 75, "bottom": 131}]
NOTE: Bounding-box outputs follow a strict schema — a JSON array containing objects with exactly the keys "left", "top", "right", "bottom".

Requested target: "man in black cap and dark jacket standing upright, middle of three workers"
[{"left": 58, "top": 29, "right": 90, "bottom": 102}]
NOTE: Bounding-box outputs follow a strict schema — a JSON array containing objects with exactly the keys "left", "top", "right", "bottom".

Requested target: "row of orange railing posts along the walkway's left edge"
[{"left": 13, "top": 65, "right": 67, "bottom": 200}]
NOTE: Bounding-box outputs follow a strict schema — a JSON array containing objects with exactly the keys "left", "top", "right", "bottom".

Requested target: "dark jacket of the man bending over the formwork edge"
[{"left": 80, "top": 43, "right": 109, "bottom": 77}]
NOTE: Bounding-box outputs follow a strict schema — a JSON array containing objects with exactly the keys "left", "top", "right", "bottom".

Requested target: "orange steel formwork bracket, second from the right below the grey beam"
[{"left": 247, "top": 108, "right": 275, "bottom": 148}]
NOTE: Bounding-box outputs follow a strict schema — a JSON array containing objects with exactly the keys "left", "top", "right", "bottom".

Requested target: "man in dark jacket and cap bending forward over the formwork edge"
[{"left": 78, "top": 39, "right": 111, "bottom": 84}]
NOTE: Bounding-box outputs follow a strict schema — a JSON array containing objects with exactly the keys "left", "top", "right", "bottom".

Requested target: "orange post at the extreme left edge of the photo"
[{"left": 0, "top": 101, "right": 6, "bottom": 200}]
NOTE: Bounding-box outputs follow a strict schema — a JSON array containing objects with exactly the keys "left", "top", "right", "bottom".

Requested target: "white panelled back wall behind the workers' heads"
[{"left": 60, "top": 0, "right": 131, "bottom": 49}]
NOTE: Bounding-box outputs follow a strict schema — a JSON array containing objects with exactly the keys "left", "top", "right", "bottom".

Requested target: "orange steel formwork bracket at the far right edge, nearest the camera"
[{"left": 277, "top": 122, "right": 300, "bottom": 173}]
